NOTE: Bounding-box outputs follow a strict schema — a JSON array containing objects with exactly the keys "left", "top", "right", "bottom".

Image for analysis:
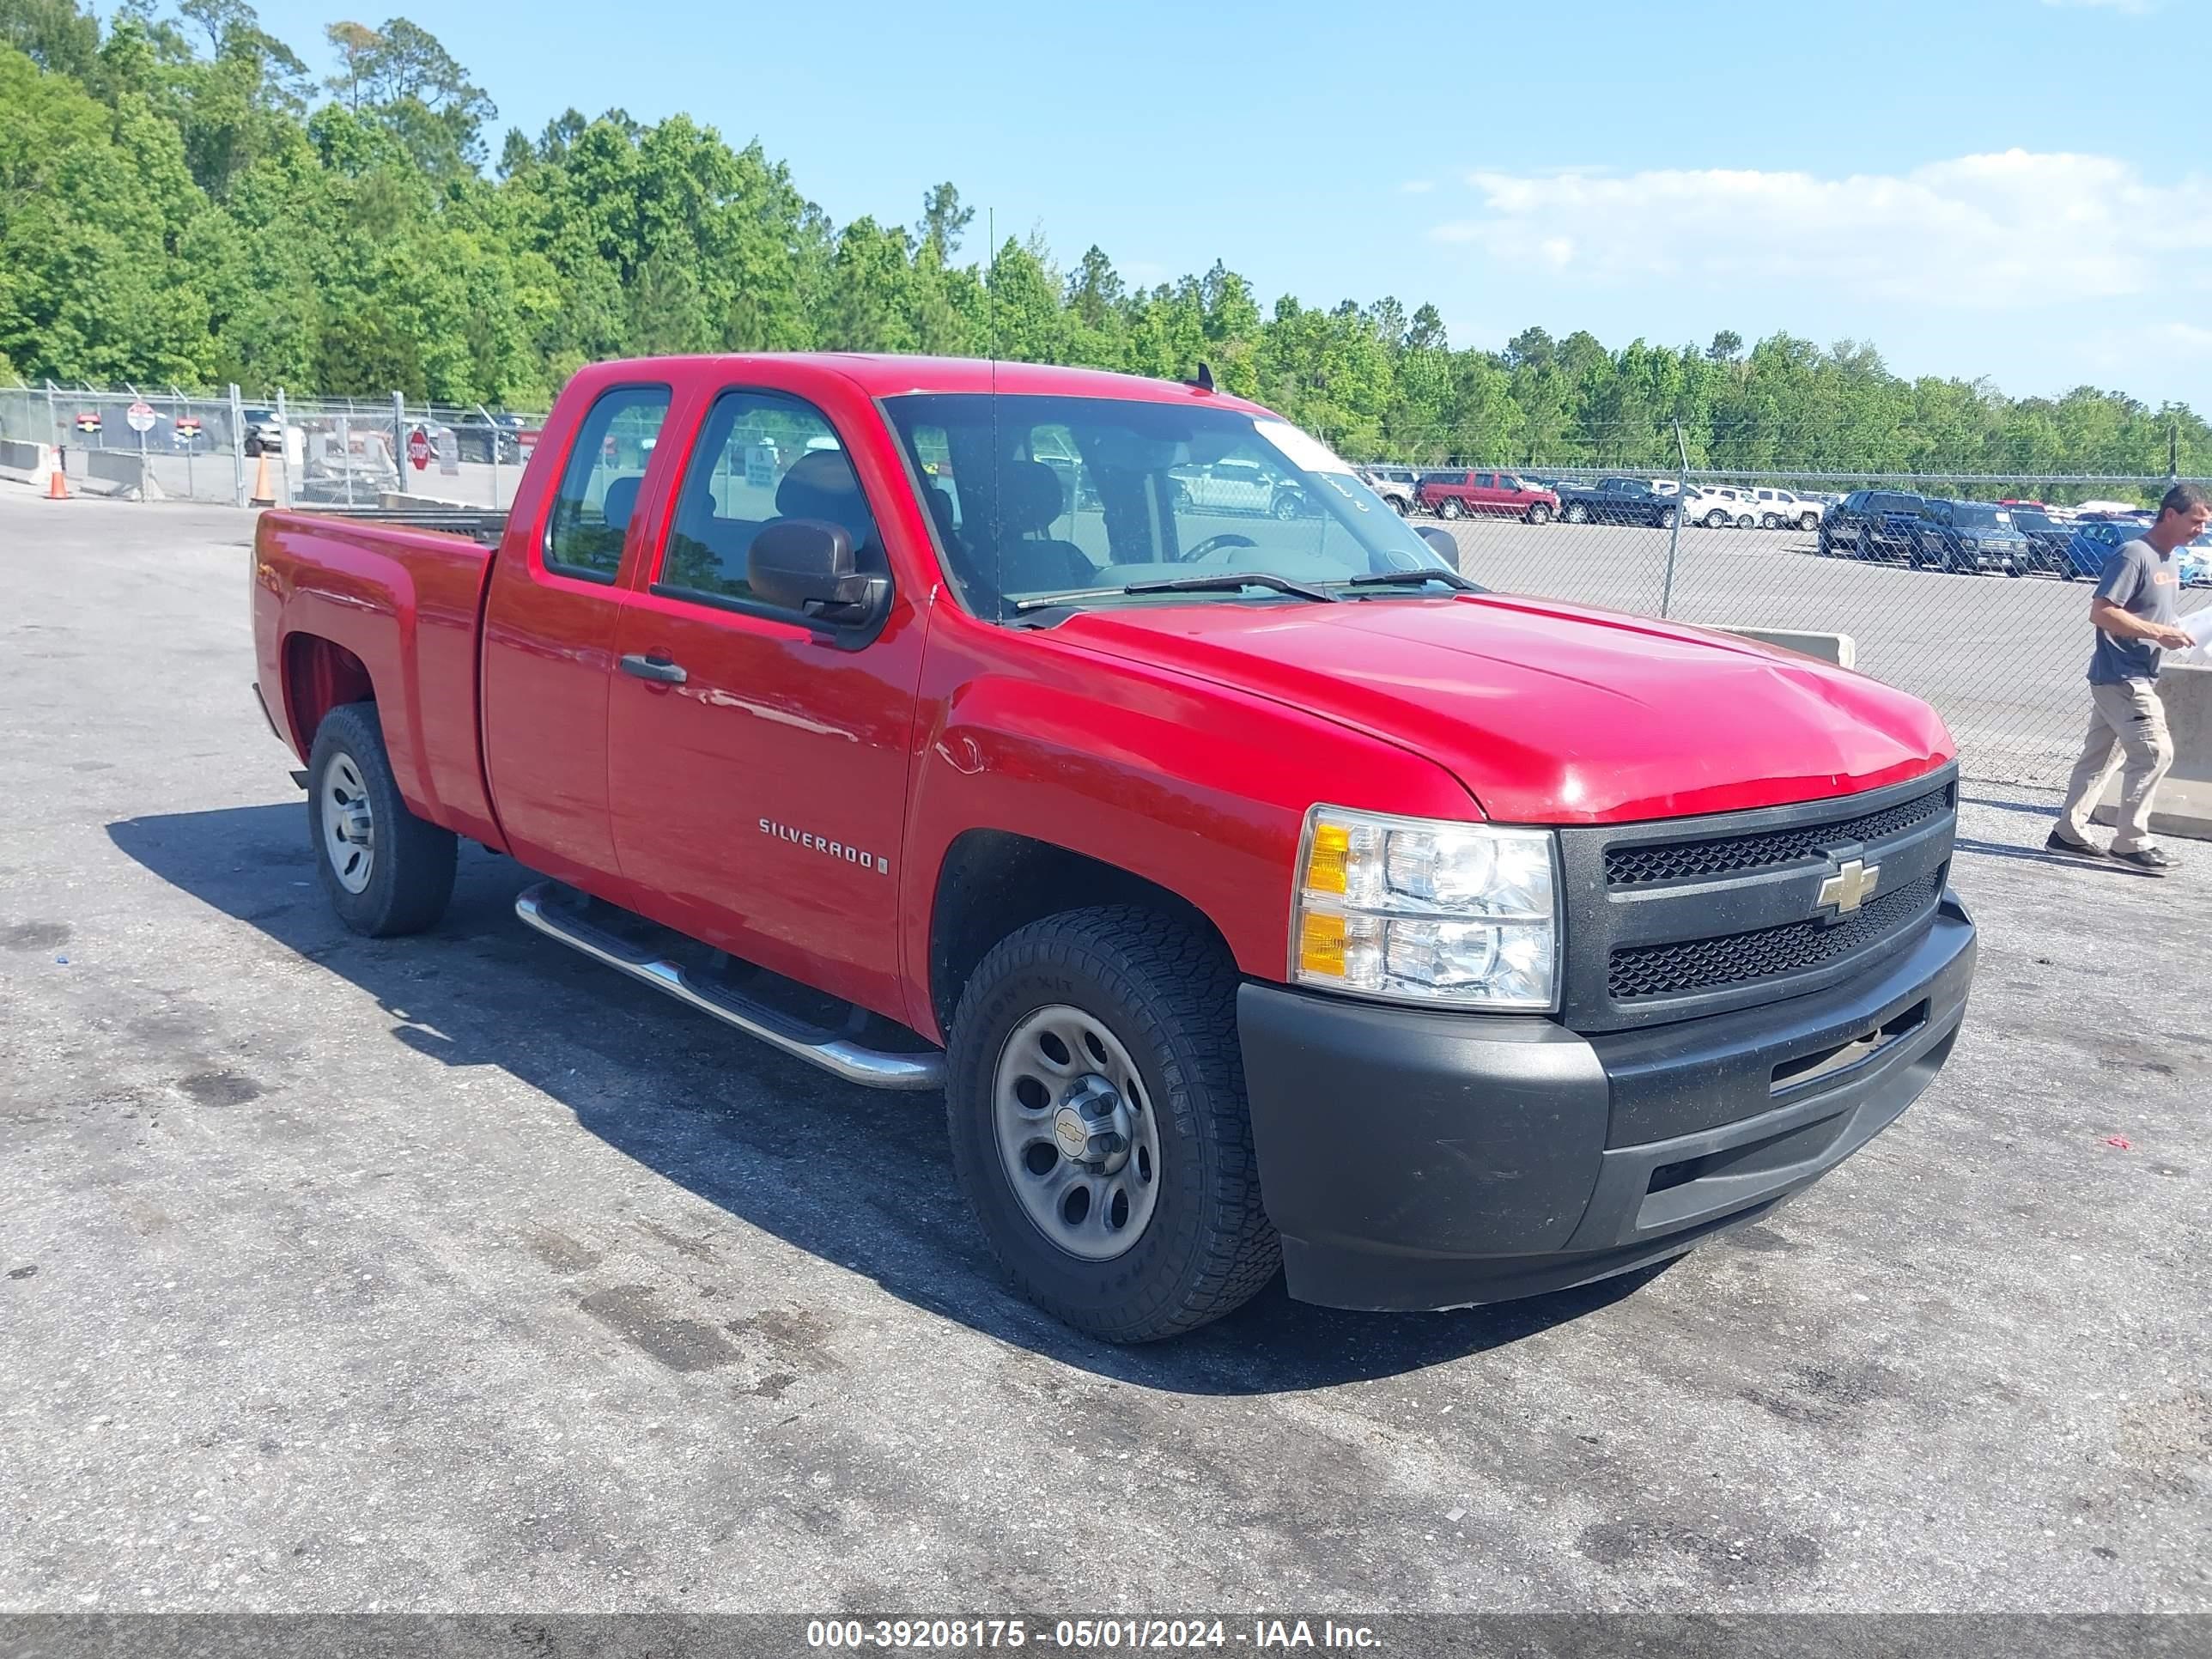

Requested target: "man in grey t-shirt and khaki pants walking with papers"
[{"left": 2044, "top": 484, "right": 2212, "bottom": 876}]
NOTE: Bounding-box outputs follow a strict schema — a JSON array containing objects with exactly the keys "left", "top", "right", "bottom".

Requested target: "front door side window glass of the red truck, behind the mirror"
[{"left": 653, "top": 392, "right": 890, "bottom": 619}]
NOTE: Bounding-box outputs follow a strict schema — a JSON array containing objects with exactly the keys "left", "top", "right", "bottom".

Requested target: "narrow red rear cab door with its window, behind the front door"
[{"left": 483, "top": 383, "right": 671, "bottom": 894}]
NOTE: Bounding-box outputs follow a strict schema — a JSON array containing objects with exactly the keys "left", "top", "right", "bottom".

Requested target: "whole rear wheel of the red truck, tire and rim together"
[{"left": 307, "top": 703, "right": 458, "bottom": 938}]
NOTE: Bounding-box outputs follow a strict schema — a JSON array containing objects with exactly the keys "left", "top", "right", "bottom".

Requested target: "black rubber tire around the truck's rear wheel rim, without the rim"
[{"left": 307, "top": 703, "right": 458, "bottom": 938}]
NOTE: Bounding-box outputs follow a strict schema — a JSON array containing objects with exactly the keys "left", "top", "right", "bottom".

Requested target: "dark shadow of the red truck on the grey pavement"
[{"left": 108, "top": 805, "right": 1663, "bottom": 1394}]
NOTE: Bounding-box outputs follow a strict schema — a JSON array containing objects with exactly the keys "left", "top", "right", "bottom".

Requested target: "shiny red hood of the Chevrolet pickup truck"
[{"left": 1055, "top": 595, "right": 1954, "bottom": 823}]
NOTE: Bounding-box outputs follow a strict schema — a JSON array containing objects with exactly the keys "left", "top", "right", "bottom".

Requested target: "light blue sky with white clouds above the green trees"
[{"left": 163, "top": 0, "right": 2212, "bottom": 411}]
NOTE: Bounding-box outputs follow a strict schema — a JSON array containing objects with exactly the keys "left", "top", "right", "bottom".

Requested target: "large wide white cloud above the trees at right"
[{"left": 1431, "top": 150, "right": 2212, "bottom": 310}]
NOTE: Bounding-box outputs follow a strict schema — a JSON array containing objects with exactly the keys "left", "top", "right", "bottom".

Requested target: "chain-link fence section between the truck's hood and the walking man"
[{"left": 1385, "top": 455, "right": 2212, "bottom": 787}]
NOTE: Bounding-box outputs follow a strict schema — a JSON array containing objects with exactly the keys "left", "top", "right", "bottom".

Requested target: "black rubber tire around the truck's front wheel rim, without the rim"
[{"left": 945, "top": 905, "right": 1283, "bottom": 1343}]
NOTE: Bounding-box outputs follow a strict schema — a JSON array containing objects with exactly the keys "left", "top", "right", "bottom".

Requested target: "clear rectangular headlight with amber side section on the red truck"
[{"left": 1290, "top": 807, "right": 1559, "bottom": 1013}]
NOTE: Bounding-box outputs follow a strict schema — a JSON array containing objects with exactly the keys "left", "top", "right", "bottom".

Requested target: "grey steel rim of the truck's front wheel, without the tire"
[{"left": 991, "top": 1002, "right": 1161, "bottom": 1261}]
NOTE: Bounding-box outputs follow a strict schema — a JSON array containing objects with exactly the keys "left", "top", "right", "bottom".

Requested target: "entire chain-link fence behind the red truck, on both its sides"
[{"left": 0, "top": 385, "right": 2212, "bottom": 787}]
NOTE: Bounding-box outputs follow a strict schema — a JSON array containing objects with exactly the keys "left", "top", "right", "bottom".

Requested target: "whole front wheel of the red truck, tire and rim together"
[{"left": 945, "top": 905, "right": 1281, "bottom": 1343}]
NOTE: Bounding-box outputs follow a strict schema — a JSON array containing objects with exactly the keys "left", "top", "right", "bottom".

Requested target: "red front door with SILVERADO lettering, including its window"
[{"left": 608, "top": 387, "right": 922, "bottom": 1020}]
